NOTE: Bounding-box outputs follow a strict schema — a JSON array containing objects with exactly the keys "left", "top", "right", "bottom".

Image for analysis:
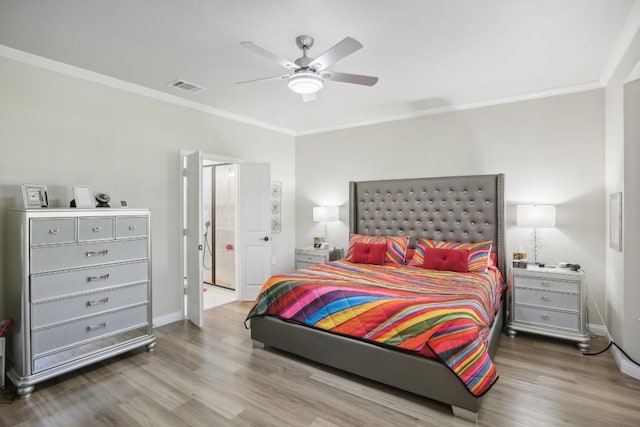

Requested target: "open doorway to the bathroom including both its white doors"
[{"left": 180, "top": 151, "right": 271, "bottom": 327}]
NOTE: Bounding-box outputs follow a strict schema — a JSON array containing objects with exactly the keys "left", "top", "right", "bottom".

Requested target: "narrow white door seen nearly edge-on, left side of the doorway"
[{"left": 186, "top": 151, "right": 204, "bottom": 328}]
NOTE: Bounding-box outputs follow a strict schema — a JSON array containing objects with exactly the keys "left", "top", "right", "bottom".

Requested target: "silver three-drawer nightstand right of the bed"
[{"left": 507, "top": 266, "right": 591, "bottom": 351}]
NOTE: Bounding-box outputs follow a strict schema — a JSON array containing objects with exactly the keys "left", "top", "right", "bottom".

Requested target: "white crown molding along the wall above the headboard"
[{"left": 296, "top": 81, "right": 603, "bottom": 136}]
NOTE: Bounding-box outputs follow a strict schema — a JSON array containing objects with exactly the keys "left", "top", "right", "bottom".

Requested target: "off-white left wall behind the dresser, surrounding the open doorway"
[{"left": 0, "top": 58, "right": 294, "bottom": 324}]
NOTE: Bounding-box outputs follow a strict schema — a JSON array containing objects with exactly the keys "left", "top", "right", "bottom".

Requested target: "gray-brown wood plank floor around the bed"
[{"left": 0, "top": 303, "right": 640, "bottom": 427}]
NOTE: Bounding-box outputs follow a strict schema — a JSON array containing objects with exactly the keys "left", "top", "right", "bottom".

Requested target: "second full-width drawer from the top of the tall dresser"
[{"left": 31, "top": 261, "right": 149, "bottom": 302}]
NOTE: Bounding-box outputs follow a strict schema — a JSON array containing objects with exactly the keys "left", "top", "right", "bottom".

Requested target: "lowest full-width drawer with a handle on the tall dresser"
[{"left": 31, "top": 304, "right": 147, "bottom": 358}]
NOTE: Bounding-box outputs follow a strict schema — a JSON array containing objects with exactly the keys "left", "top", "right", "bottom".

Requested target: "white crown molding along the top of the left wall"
[{"left": 0, "top": 45, "right": 295, "bottom": 136}]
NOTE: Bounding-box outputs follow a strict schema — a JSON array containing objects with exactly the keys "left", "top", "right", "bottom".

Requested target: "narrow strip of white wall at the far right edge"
[{"left": 605, "top": 22, "right": 640, "bottom": 368}]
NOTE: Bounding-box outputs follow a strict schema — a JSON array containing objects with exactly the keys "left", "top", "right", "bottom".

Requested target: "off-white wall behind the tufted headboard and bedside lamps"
[{"left": 296, "top": 90, "right": 605, "bottom": 332}]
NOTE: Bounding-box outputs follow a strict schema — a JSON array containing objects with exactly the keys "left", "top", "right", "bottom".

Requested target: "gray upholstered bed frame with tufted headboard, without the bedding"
[{"left": 251, "top": 174, "right": 506, "bottom": 422}]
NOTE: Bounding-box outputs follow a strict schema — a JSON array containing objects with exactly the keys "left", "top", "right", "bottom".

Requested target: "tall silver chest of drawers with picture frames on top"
[{"left": 5, "top": 209, "right": 155, "bottom": 397}]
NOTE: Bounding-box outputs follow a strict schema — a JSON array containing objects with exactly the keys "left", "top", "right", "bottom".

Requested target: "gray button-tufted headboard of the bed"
[{"left": 349, "top": 174, "right": 506, "bottom": 277}]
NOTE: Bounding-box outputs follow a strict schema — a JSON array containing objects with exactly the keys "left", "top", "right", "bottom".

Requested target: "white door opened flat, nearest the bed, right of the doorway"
[{"left": 238, "top": 163, "right": 271, "bottom": 301}]
